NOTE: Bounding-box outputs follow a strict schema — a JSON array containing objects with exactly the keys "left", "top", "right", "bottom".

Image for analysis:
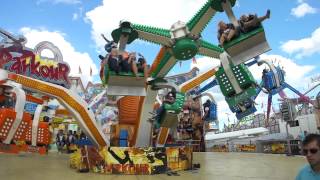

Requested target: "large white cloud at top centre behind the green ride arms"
[{"left": 84, "top": 0, "right": 206, "bottom": 48}]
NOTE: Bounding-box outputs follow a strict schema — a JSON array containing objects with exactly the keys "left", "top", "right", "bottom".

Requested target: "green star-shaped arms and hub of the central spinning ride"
[{"left": 109, "top": 0, "right": 236, "bottom": 78}]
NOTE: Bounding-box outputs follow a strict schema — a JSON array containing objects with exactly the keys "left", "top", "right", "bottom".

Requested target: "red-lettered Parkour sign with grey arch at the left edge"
[{"left": 0, "top": 29, "right": 70, "bottom": 88}]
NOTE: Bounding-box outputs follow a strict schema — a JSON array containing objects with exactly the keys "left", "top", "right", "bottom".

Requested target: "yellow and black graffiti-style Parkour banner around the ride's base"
[{"left": 70, "top": 146, "right": 192, "bottom": 175}]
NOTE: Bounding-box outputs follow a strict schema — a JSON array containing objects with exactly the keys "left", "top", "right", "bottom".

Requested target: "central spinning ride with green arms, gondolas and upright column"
[{"left": 102, "top": 1, "right": 270, "bottom": 146}]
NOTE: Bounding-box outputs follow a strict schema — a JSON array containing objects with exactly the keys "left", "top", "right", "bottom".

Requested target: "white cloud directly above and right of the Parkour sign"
[{"left": 20, "top": 27, "right": 98, "bottom": 85}]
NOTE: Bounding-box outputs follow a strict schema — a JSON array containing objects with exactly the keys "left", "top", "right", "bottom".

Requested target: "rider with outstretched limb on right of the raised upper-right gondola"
[{"left": 239, "top": 9, "right": 270, "bottom": 33}]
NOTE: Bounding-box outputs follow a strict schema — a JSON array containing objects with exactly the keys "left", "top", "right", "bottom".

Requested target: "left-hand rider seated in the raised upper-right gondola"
[{"left": 218, "top": 21, "right": 239, "bottom": 46}]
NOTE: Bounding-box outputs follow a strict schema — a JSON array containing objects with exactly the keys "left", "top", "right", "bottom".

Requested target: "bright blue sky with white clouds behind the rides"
[{"left": 0, "top": 0, "right": 320, "bottom": 129}]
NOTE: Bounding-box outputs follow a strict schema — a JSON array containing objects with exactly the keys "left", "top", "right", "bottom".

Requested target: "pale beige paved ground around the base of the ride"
[{"left": 0, "top": 153, "right": 306, "bottom": 180}]
